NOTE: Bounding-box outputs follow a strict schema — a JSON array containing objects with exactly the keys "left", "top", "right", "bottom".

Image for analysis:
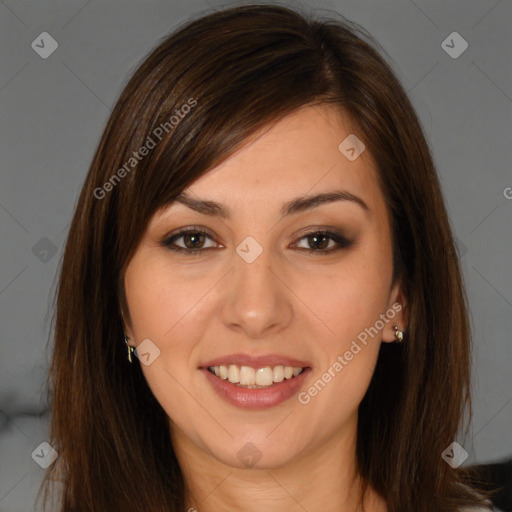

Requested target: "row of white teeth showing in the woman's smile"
[{"left": 209, "top": 364, "right": 303, "bottom": 388}]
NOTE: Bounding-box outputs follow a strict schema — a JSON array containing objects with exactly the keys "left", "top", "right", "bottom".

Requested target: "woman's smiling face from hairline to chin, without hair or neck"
[{"left": 125, "top": 106, "right": 404, "bottom": 468}]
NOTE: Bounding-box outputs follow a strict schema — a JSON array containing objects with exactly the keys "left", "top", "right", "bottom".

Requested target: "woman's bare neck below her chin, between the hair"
[{"left": 171, "top": 418, "right": 386, "bottom": 512}]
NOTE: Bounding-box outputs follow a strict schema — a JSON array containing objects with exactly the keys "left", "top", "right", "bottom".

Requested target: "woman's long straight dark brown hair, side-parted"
[{"left": 41, "top": 5, "right": 492, "bottom": 512}]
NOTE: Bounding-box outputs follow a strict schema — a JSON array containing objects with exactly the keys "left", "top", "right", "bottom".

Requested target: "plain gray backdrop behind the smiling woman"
[{"left": 0, "top": 0, "right": 512, "bottom": 512}]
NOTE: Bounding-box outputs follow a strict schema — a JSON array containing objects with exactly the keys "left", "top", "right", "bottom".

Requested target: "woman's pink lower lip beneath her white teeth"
[{"left": 200, "top": 368, "right": 311, "bottom": 409}]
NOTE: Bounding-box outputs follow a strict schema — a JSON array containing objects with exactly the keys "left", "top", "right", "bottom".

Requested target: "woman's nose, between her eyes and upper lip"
[{"left": 221, "top": 243, "right": 294, "bottom": 340}]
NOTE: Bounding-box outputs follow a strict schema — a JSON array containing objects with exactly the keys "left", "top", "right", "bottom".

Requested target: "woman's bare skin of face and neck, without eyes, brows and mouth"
[{"left": 125, "top": 105, "right": 406, "bottom": 512}]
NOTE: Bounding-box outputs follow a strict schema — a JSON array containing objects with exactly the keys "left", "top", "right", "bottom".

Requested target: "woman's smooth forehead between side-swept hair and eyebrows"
[{"left": 154, "top": 105, "right": 384, "bottom": 222}]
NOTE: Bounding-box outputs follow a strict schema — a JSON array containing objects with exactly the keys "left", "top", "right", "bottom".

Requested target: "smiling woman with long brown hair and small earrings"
[{"left": 39, "top": 5, "right": 496, "bottom": 512}]
